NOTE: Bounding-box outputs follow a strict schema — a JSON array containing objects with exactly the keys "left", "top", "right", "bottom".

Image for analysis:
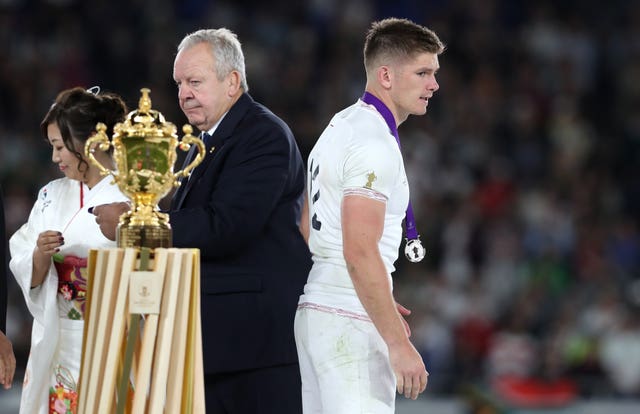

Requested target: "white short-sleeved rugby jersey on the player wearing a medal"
[{"left": 300, "top": 100, "right": 409, "bottom": 312}]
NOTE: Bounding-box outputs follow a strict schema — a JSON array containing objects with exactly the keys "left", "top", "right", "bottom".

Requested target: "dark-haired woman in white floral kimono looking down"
[{"left": 9, "top": 88, "right": 127, "bottom": 414}]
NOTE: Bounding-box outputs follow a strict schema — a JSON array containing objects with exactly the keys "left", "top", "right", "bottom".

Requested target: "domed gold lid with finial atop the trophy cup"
[{"left": 114, "top": 88, "right": 177, "bottom": 138}]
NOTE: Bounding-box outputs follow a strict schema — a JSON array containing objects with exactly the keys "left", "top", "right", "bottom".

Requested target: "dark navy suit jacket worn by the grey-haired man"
[{"left": 169, "top": 93, "right": 311, "bottom": 374}]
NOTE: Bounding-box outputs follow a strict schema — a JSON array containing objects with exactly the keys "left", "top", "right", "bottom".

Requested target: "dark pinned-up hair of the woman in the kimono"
[{"left": 40, "top": 87, "right": 127, "bottom": 175}]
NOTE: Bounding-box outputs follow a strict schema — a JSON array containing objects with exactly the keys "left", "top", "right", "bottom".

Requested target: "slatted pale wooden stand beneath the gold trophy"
[{"left": 78, "top": 248, "right": 205, "bottom": 414}]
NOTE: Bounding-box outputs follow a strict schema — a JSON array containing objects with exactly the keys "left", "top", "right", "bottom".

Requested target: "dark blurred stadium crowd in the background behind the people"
[{"left": 0, "top": 0, "right": 640, "bottom": 405}]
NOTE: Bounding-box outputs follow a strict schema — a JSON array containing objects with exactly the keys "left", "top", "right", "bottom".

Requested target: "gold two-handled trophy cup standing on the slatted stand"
[{"left": 84, "top": 88, "right": 205, "bottom": 249}]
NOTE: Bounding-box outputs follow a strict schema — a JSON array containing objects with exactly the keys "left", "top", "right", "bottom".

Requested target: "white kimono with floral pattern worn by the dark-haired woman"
[{"left": 9, "top": 176, "right": 128, "bottom": 414}]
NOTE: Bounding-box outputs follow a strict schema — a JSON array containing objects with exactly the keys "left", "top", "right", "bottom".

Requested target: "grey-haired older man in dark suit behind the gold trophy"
[{"left": 93, "top": 29, "right": 311, "bottom": 414}]
